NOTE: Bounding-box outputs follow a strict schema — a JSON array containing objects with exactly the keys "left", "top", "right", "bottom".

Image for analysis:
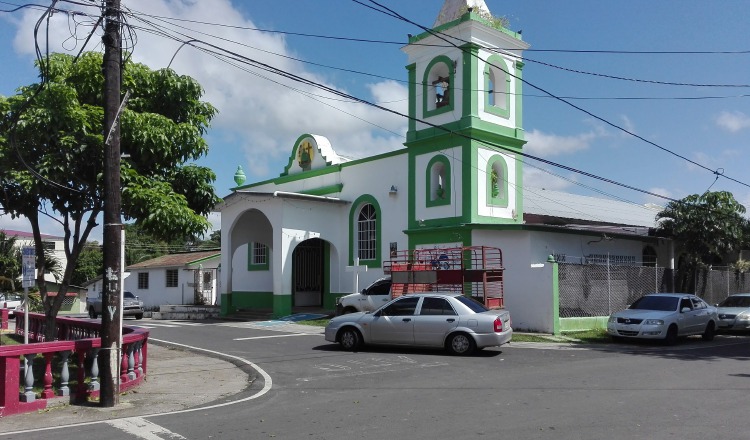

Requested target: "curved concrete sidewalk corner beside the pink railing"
[{"left": 0, "top": 342, "right": 254, "bottom": 434}]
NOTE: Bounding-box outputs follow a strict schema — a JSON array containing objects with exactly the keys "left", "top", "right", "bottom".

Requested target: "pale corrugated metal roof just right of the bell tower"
[{"left": 523, "top": 188, "right": 662, "bottom": 227}]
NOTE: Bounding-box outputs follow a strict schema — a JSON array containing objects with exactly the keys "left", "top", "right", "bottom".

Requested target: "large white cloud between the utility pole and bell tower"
[{"left": 8, "top": 0, "right": 407, "bottom": 183}]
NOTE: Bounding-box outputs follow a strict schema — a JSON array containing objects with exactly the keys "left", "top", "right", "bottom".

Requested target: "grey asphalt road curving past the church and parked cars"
[{"left": 0, "top": 320, "right": 750, "bottom": 440}]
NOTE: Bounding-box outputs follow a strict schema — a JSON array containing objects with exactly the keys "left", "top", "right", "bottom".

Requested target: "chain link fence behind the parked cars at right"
[{"left": 558, "top": 257, "right": 750, "bottom": 318}]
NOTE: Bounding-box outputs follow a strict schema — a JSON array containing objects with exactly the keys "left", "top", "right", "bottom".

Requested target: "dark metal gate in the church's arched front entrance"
[{"left": 292, "top": 238, "right": 325, "bottom": 307}]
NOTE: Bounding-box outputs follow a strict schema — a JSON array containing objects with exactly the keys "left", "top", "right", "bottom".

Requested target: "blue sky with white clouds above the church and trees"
[{"left": 0, "top": 0, "right": 750, "bottom": 239}]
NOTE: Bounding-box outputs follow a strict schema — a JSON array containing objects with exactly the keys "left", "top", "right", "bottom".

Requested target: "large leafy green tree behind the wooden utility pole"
[{"left": 0, "top": 52, "right": 220, "bottom": 334}]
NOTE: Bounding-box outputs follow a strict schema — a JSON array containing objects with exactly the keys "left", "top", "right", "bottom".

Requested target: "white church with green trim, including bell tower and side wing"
[{"left": 217, "top": 0, "right": 673, "bottom": 331}]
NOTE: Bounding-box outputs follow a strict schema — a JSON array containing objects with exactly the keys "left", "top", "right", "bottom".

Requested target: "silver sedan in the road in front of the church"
[{"left": 325, "top": 293, "right": 513, "bottom": 355}]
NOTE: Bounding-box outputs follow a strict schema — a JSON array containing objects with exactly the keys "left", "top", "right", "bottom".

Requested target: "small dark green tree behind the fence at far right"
[{"left": 656, "top": 191, "right": 748, "bottom": 292}]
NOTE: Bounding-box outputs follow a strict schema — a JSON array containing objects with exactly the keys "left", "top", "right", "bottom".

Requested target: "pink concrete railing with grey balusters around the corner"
[{"left": 0, "top": 312, "right": 149, "bottom": 417}]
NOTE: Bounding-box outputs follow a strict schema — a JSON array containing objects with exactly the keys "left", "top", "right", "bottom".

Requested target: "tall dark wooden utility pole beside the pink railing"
[{"left": 98, "top": 0, "right": 123, "bottom": 407}]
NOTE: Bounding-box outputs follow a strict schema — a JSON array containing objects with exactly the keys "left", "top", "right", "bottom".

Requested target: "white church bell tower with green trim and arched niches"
[{"left": 402, "top": 0, "right": 529, "bottom": 245}]
